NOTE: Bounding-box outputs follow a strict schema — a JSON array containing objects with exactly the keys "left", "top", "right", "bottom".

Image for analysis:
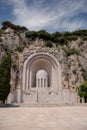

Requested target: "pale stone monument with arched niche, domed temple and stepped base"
[{"left": 8, "top": 41, "right": 77, "bottom": 104}]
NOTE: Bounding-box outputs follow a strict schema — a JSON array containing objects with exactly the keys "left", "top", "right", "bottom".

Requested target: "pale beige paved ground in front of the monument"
[{"left": 0, "top": 106, "right": 87, "bottom": 130}]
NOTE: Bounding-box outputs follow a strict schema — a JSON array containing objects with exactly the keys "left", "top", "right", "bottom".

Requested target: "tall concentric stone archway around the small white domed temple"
[{"left": 23, "top": 52, "right": 61, "bottom": 91}]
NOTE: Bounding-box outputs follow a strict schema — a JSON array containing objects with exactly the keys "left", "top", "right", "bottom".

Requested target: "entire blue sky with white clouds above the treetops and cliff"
[{"left": 0, "top": 0, "right": 87, "bottom": 32}]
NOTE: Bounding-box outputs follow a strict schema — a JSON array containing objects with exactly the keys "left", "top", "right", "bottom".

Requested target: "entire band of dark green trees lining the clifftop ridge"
[{"left": 2, "top": 21, "right": 87, "bottom": 46}]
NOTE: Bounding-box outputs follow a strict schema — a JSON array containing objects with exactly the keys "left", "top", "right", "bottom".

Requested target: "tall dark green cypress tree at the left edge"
[{"left": 0, "top": 55, "right": 11, "bottom": 103}]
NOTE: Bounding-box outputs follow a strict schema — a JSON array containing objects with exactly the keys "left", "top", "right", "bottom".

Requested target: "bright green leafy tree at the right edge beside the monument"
[{"left": 78, "top": 81, "right": 87, "bottom": 102}]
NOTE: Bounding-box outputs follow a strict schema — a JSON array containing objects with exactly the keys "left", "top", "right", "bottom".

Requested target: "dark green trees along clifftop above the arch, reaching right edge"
[{"left": 26, "top": 30, "right": 87, "bottom": 45}]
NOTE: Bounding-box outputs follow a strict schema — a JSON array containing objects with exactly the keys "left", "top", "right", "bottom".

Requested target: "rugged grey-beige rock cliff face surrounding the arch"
[{"left": 0, "top": 28, "right": 87, "bottom": 91}]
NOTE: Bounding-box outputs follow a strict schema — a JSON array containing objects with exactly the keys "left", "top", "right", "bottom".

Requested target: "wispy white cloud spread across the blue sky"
[{"left": 9, "top": 0, "right": 87, "bottom": 31}]
